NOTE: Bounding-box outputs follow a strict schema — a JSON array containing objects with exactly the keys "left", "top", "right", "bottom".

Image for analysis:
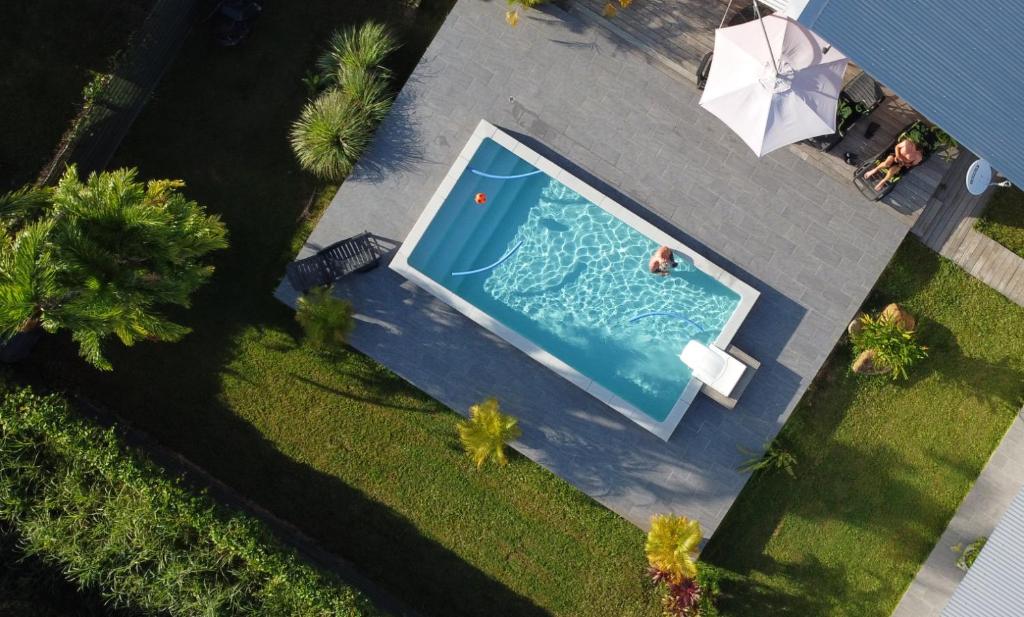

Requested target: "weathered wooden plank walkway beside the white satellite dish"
[{"left": 910, "top": 153, "right": 1024, "bottom": 306}]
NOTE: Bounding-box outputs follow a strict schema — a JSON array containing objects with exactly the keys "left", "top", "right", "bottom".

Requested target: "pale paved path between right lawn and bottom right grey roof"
[{"left": 893, "top": 408, "right": 1024, "bottom": 617}]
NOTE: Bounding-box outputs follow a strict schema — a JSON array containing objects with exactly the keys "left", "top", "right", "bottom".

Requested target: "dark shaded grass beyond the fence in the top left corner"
[{"left": 0, "top": 0, "right": 152, "bottom": 191}]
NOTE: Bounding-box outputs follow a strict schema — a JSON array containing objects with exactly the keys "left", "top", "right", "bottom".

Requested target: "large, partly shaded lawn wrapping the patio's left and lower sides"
[{"left": 8, "top": 0, "right": 658, "bottom": 617}]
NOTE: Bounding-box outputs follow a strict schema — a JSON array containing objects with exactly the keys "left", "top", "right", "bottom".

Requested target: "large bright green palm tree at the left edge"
[{"left": 0, "top": 167, "right": 227, "bottom": 370}]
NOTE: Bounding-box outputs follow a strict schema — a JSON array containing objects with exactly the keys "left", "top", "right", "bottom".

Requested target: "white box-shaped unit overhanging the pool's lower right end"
[{"left": 679, "top": 341, "right": 761, "bottom": 409}]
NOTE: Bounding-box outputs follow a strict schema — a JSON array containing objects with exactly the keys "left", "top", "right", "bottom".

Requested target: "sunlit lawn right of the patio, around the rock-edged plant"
[{"left": 702, "top": 239, "right": 1024, "bottom": 617}]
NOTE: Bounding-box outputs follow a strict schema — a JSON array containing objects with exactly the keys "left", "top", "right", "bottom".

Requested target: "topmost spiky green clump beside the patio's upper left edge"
[{"left": 316, "top": 21, "right": 398, "bottom": 90}]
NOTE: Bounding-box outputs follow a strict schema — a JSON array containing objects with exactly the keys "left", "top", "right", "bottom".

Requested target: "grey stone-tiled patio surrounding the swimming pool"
[{"left": 279, "top": 0, "right": 909, "bottom": 537}]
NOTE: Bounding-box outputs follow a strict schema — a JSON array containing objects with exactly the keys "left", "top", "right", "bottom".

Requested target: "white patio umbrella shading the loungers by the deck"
[{"left": 700, "top": 15, "right": 847, "bottom": 157}]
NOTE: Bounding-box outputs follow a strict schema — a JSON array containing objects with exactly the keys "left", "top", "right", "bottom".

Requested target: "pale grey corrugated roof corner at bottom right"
[{"left": 942, "top": 490, "right": 1024, "bottom": 617}]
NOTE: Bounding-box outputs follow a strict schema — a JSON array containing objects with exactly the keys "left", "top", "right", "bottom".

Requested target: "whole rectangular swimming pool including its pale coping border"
[{"left": 391, "top": 121, "right": 758, "bottom": 439}]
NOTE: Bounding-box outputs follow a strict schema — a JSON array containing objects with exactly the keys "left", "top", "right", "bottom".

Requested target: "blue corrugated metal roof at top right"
[{"left": 798, "top": 0, "right": 1024, "bottom": 185}]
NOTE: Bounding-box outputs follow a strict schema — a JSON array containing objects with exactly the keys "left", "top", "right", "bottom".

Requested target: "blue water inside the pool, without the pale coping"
[{"left": 409, "top": 139, "right": 739, "bottom": 421}]
